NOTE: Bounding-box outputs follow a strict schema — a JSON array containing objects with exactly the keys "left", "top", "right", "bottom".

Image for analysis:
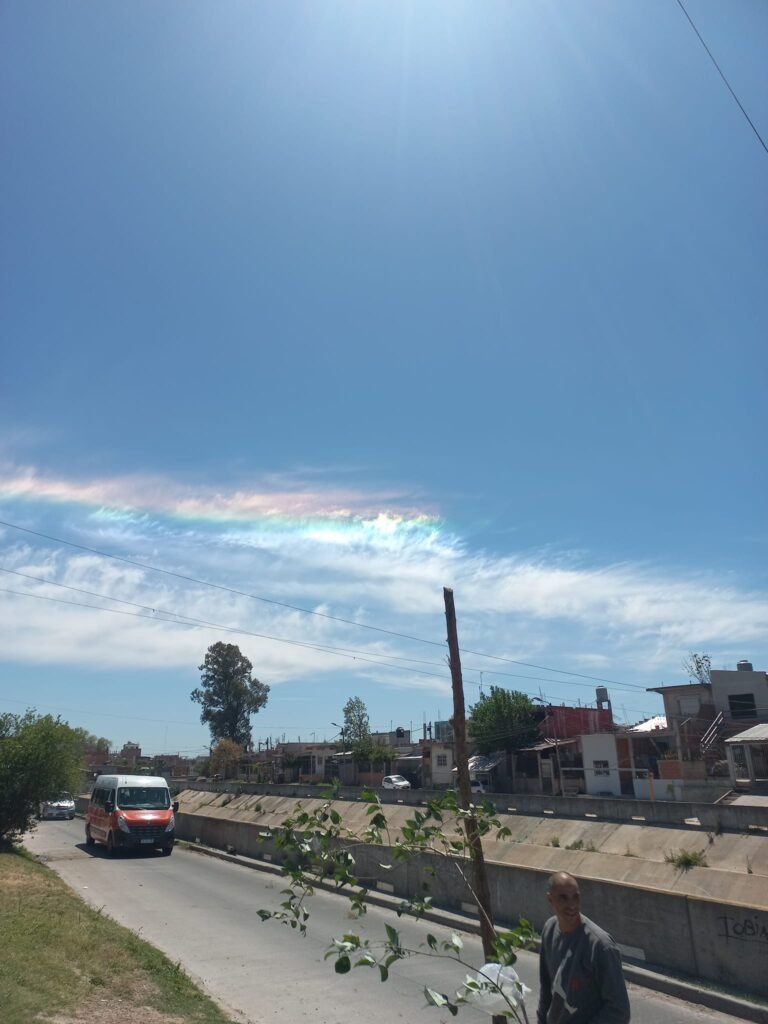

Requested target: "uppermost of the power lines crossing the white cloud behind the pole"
[{"left": 0, "top": 519, "right": 645, "bottom": 690}]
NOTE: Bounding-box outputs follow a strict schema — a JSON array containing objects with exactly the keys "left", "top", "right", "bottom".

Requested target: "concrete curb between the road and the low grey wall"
[{"left": 176, "top": 840, "right": 768, "bottom": 1024}]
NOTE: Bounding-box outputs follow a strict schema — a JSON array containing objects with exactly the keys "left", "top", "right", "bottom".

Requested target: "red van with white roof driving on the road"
[{"left": 85, "top": 775, "right": 178, "bottom": 856}]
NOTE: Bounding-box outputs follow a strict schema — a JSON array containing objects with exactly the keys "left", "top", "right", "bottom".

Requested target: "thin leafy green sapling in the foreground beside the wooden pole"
[{"left": 258, "top": 791, "right": 534, "bottom": 1024}]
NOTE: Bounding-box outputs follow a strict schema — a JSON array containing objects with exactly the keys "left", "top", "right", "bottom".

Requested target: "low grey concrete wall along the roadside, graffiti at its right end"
[{"left": 177, "top": 807, "right": 768, "bottom": 994}]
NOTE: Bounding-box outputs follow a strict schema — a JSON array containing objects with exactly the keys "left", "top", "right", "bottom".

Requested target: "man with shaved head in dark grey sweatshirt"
[{"left": 538, "top": 871, "right": 630, "bottom": 1024}]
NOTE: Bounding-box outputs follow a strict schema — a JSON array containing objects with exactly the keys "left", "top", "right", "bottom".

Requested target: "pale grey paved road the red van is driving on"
[{"left": 26, "top": 819, "right": 749, "bottom": 1024}]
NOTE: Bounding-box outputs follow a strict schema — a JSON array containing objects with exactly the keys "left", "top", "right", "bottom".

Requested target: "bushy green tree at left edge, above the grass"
[{"left": 0, "top": 711, "right": 83, "bottom": 845}]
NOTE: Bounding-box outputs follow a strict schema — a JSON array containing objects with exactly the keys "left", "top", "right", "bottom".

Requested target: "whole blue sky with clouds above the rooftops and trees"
[{"left": 0, "top": 0, "right": 768, "bottom": 752}]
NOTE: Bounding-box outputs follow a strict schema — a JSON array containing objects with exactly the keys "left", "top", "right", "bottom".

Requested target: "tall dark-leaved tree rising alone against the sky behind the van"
[{"left": 190, "top": 641, "right": 269, "bottom": 751}]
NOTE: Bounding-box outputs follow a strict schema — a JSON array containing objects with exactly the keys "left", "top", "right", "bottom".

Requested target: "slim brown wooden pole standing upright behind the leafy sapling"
[{"left": 442, "top": 587, "right": 504, "bottom": 1024}]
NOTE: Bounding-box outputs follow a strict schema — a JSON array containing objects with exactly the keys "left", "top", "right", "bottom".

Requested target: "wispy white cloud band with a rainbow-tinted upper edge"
[{"left": 0, "top": 464, "right": 768, "bottom": 704}]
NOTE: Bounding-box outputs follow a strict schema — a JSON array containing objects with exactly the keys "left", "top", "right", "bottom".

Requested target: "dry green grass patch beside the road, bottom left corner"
[{"left": 0, "top": 849, "right": 230, "bottom": 1024}]
